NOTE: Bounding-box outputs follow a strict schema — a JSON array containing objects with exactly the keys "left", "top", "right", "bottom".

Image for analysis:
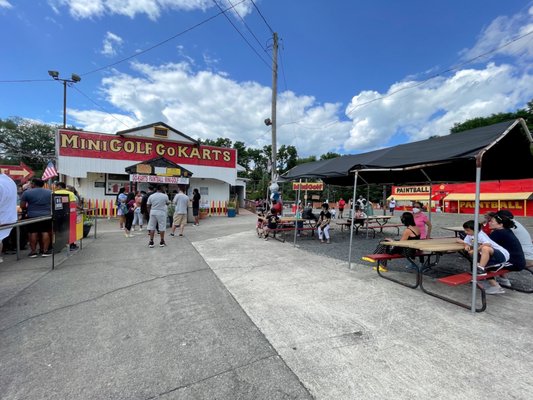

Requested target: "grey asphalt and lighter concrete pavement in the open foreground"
[{"left": 0, "top": 213, "right": 533, "bottom": 400}]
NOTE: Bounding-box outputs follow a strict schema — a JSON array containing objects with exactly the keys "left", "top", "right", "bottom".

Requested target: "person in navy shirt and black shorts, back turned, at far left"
[{"left": 20, "top": 178, "right": 52, "bottom": 258}]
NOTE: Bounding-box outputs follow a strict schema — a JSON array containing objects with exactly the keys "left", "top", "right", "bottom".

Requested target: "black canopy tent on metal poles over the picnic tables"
[{"left": 283, "top": 119, "right": 533, "bottom": 312}]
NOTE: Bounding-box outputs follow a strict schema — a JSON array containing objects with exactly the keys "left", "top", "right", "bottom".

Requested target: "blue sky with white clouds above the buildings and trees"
[{"left": 0, "top": 0, "right": 533, "bottom": 157}]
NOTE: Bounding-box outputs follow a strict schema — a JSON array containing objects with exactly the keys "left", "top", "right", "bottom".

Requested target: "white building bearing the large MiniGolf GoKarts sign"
[{"left": 56, "top": 122, "right": 246, "bottom": 211}]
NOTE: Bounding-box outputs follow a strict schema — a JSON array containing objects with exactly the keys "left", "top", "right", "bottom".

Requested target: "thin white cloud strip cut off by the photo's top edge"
[{"left": 47, "top": 0, "right": 253, "bottom": 20}]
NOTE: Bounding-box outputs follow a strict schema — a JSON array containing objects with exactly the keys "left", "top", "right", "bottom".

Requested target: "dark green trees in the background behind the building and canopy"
[{"left": 0, "top": 100, "right": 533, "bottom": 202}]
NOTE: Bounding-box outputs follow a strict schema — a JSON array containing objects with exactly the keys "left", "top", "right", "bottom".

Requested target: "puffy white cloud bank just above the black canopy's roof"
[{"left": 344, "top": 63, "right": 533, "bottom": 151}]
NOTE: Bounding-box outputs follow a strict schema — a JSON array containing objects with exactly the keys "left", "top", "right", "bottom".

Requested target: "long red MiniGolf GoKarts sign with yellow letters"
[{"left": 57, "top": 129, "right": 237, "bottom": 168}]
